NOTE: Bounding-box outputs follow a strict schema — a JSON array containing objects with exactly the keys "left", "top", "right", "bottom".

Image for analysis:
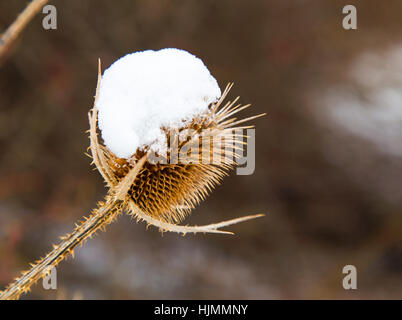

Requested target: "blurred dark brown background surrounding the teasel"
[{"left": 0, "top": 0, "right": 402, "bottom": 299}]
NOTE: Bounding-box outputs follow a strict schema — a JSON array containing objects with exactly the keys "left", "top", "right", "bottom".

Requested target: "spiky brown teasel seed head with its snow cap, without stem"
[{"left": 96, "top": 49, "right": 264, "bottom": 223}]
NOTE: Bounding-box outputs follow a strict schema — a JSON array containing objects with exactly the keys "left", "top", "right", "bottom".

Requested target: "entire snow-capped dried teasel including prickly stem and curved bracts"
[{"left": 0, "top": 49, "right": 262, "bottom": 299}]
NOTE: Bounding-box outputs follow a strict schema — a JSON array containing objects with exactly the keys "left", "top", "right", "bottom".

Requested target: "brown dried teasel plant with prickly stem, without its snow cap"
[{"left": 0, "top": 61, "right": 264, "bottom": 299}]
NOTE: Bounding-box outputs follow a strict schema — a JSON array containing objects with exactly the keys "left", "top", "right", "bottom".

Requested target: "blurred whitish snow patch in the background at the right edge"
[{"left": 324, "top": 45, "right": 402, "bottom": 157}]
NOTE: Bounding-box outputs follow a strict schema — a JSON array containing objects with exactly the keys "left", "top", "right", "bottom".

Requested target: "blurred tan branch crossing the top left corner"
[{"left": 0, "top": 0, "right": 48, "bottom": 62}]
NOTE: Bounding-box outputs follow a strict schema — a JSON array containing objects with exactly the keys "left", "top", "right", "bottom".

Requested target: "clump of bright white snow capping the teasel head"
[{"left": 96, "top": 48, "right": 221, "bottom": 158}]
